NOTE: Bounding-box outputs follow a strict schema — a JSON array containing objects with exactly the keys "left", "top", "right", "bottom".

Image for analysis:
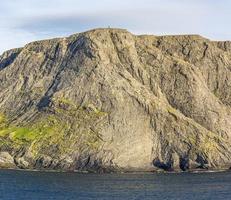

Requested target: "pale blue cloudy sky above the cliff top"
[{"left": 0, "top": 0, "right": 231, "bottom": 53}]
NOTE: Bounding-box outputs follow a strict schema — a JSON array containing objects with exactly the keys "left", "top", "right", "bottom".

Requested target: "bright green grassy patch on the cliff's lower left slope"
[{"left": 0, "top": 98, "right": 105, "bottom": 156}]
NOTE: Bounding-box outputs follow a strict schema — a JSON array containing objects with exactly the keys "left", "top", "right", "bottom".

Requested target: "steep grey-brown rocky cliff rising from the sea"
[{"left": 0, "top": 29, "right": 231, "bottom": 171}]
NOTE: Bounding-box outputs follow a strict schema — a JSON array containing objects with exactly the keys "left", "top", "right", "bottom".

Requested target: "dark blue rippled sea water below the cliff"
[{"left": 0, "top": 170, "right": 231, "bottom": 200}]
